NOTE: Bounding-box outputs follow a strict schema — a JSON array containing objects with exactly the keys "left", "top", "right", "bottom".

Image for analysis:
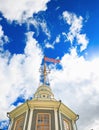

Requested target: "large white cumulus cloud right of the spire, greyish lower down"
[{"left": 50, "top": 49, "right": 99, "bottom": 130}]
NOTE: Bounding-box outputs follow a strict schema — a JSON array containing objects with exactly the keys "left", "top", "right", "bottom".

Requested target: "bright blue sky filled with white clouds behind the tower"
[{"left": 0, "top": 0, "right": 99, "bottom": 130}]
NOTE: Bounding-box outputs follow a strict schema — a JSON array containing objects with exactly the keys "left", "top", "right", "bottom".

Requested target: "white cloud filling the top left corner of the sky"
[{"left": 0, "top": 0, "right": 49, "bottom": 23}]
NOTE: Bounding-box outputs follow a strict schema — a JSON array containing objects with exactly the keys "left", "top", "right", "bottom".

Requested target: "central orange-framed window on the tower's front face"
[{"left": 36, "top": 113, "right": 50, "bottom": 130}]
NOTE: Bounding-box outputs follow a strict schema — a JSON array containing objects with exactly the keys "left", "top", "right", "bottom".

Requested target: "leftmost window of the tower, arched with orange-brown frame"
[{"left": 14, "top": 116, "right": 24, "bottom": 130}]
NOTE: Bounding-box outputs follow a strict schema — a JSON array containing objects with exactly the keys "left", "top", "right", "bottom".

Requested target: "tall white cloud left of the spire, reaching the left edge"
[{"left": 0, "top": 32, "right": 42, "bottom": 121}]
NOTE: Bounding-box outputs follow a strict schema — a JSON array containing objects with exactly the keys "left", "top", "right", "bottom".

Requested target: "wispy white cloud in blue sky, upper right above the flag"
[{"left": 63, "top": 11, "right": 88, "bottom": 51}]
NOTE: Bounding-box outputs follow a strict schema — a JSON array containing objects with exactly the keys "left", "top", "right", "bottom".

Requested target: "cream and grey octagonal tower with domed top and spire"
[{"left": 8, "top": 57, "right": 78, "bottom": 130}]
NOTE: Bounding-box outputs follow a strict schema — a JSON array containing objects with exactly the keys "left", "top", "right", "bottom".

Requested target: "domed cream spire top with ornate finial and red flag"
[{"left": 34, "top": 56, "right": 60, "bottom": 100}]
